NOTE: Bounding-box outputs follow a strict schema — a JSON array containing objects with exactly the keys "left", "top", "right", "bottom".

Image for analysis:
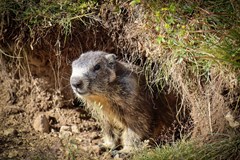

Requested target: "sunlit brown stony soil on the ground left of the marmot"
[{"left": 0, "top": 59, "right": 116, "bottom": 160}]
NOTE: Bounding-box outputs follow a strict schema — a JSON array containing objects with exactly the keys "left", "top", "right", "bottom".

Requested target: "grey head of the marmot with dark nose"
[{"left": 70, "top": 51, "right": 116, "bottom": 97}]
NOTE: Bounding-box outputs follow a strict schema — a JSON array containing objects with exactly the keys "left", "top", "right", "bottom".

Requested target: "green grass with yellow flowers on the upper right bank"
[{"left": 142, "top": 0, "right": 240, "bottom": 89}]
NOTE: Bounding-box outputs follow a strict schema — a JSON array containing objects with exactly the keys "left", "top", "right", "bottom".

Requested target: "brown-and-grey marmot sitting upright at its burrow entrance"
[{"left": 70, "top": 51, "right": 176, "bottom": 152}]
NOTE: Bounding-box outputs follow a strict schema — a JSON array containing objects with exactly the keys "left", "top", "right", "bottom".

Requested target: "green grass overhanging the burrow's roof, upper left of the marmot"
[{"left": 0, "top": 0, "right": 97, "bottom": 38}]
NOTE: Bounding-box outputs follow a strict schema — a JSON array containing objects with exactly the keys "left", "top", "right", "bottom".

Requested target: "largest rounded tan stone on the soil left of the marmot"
[{"left": 33, "top": 114, "right": 49, "bottom": 133}]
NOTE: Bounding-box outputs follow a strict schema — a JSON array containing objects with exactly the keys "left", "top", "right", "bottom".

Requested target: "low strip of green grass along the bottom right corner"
[{"left": 133, "top": 136, "right": 240, "bottom": 160}]
